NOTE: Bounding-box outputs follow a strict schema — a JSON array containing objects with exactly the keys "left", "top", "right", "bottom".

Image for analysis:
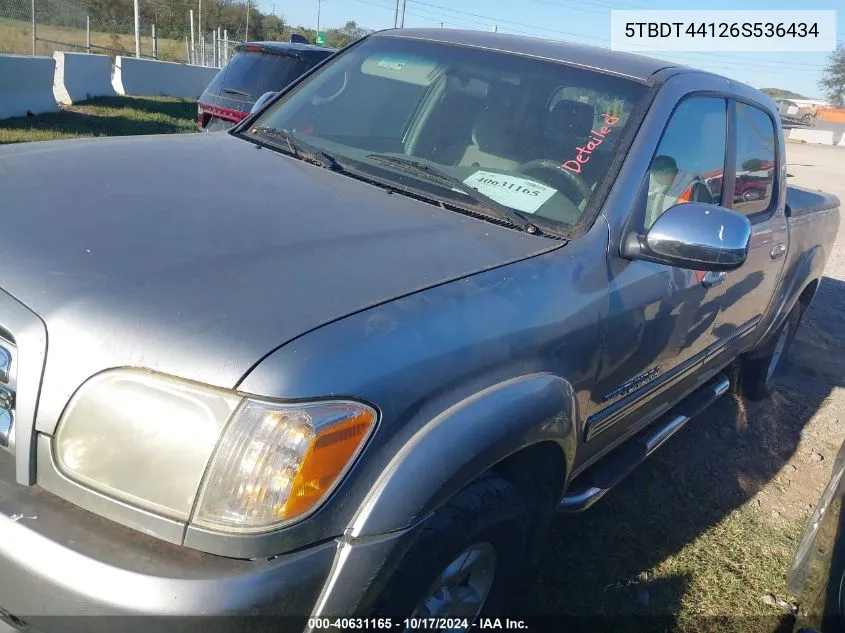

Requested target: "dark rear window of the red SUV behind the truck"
[{"left": 209, "top": 51, "right": 313, "bottom": 99}]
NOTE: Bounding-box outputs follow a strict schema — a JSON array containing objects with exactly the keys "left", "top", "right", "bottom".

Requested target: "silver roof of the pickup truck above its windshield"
[{"left": 375, "top": 29, "right": 679, "bottom": 81}]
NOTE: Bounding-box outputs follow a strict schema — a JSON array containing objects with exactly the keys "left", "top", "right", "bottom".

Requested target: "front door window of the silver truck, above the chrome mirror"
[{"left": 645, "top": 97, "right": 728, "bottom": 229}]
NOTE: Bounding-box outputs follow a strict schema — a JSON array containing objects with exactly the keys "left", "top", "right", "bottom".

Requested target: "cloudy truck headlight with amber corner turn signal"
[{"left": 55, "top": 369, "right": 376, "bottom": 533}]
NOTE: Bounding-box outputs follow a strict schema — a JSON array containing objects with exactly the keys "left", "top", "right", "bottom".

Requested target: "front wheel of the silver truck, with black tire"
[{"left": 374, "top": 474, "right": 531, "bottom": 632}]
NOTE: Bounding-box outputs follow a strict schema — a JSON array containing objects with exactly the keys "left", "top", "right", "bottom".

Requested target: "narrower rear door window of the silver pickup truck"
[{"left": 733, "top": 103, "right": 776, "bottom": 215}]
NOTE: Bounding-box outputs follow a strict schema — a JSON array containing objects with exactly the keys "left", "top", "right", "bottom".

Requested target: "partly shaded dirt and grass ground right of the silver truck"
[{"left": 518, "top": 144, "right": 845, "bottom": 633}]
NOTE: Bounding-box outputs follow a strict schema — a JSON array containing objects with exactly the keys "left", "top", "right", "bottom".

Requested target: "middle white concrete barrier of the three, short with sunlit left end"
[{"left": 53, "top": 52, "right": 117, "bottom": 105}]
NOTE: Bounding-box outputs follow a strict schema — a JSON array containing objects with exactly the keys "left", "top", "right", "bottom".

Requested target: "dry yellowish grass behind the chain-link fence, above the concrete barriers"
[{"left": 0, "top": 16, "right": 187, "bottom": 62}]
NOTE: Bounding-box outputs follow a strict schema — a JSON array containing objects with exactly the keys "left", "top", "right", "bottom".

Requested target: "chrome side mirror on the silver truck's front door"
[{"left": 622, "top": 202, "right": 751, "bottom": 271}]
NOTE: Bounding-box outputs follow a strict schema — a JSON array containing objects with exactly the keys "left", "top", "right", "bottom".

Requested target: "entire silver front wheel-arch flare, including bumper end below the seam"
[{"left": 306, "top": 373, "right": 577, "bottom": 616}]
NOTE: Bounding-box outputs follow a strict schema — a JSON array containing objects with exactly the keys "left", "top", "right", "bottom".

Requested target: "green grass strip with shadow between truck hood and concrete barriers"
[{"left": 0, "top": 97, "right": 197, "bottom": 144}]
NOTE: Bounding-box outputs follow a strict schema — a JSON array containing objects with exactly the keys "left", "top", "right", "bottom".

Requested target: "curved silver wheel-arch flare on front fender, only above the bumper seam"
[{"left": 346, "top": 374, "right": 577, "bottom": 538}]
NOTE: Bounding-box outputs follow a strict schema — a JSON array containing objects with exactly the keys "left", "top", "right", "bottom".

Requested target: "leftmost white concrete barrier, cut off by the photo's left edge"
[{"left": 0, "top": 55, "right": 58, "bottom": 119}]
